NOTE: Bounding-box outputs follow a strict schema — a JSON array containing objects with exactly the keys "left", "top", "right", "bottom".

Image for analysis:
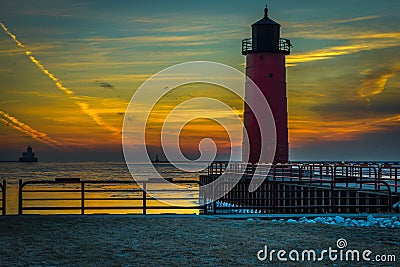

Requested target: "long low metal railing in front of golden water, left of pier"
[{"left": 18, "top": 179, "right": 207, "bottom": 214}]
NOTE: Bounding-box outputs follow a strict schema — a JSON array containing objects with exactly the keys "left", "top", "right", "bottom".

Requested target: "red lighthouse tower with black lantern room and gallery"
[{"left": 242, "top": 7, "right": 291, "bottom": 163}]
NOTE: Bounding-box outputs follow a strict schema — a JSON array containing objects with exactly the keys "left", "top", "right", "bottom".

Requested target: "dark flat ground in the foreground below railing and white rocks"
[{"left": 0, "top": 215, "right": 400, "bottom": 266}]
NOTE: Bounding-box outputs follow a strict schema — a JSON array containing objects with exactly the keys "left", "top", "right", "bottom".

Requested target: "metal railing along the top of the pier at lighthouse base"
[{"left": 208, "top": 162, "right": 400, "bottom": 193}]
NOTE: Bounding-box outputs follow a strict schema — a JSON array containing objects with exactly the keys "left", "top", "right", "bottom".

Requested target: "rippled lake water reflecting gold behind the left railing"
[{"left": 0, "top": 162, "right": 206, "bottom": 214}]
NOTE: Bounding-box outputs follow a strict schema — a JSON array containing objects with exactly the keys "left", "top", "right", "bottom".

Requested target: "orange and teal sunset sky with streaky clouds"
[{"left": 0, "top": 0, "right": 400, "bottom": 161}]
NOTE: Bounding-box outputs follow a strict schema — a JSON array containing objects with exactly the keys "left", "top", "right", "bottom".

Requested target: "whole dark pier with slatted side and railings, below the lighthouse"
[{"left": 200, "top": 162, "right": 400, "bottom": 214}]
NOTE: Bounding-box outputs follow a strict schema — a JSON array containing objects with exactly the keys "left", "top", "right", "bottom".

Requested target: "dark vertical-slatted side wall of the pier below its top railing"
[{"left": 208, "top": 179, "right": 392, "bottom": 214}]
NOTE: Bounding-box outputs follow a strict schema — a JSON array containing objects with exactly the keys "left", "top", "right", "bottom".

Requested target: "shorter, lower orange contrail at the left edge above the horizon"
[{"left": 0, "top": 110, "right": 62, "bottom": 147}]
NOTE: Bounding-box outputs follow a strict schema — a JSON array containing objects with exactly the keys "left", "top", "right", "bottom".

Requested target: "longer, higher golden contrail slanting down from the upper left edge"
[{"left": 0, "top": 22, "right": 120, "bottom": 134}]
